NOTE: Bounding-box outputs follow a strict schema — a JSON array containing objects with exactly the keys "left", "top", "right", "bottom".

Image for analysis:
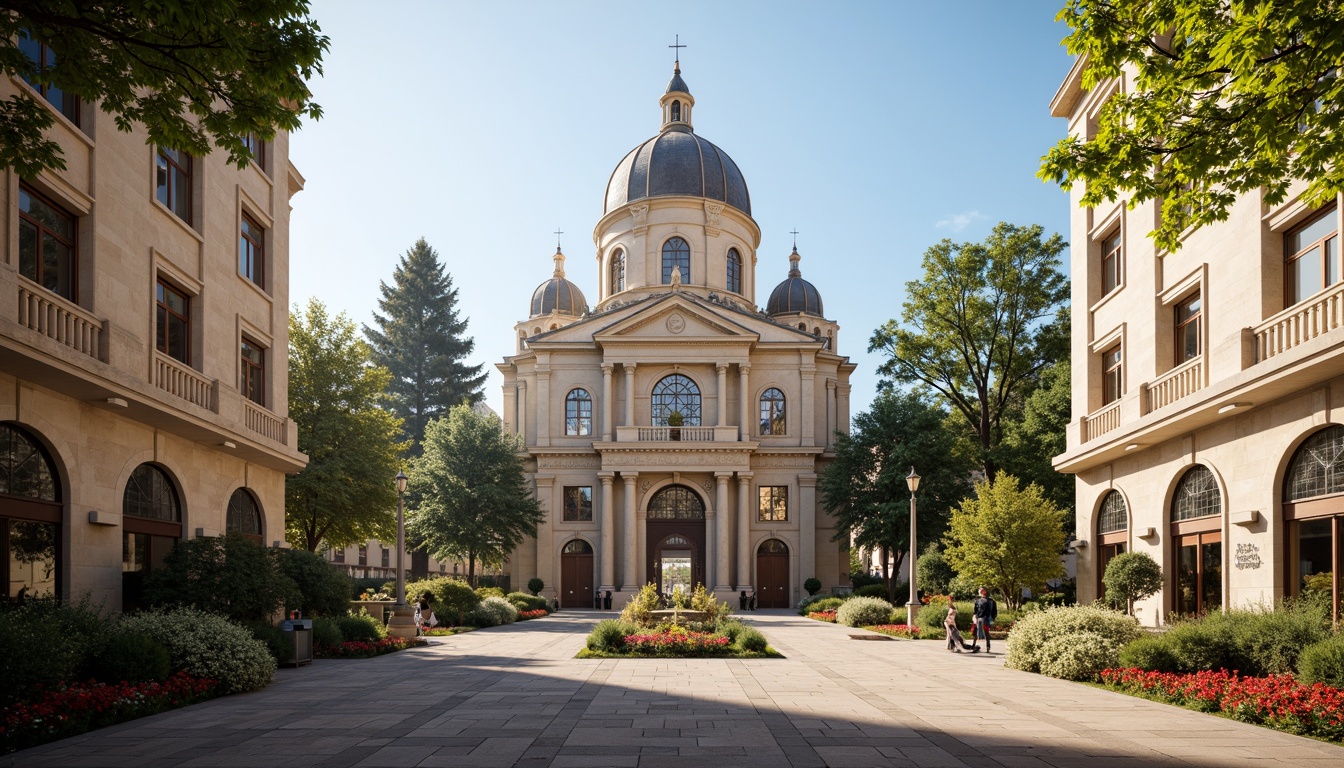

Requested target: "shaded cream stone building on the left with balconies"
[{"left": 0, "top": 66, "right": 306, "bottom": 608}]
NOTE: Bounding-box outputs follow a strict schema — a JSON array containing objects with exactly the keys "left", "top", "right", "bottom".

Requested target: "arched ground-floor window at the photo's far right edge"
[{"left": 1284, "top": 424, "right": 1344, "bottom": 621}]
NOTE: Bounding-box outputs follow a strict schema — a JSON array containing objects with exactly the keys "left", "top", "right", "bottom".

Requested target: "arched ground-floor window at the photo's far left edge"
[{"left": 0, "top": 424, "right": 62, "bottom": 605}]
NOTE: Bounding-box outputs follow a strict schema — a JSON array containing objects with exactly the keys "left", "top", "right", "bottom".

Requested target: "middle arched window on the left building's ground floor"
[{"left": 121, "top": 464, "right": 181, "bottom": 611}]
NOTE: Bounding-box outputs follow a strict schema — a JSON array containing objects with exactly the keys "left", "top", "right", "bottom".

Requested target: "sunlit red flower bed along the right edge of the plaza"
[{"left": 1101, "top": 667, "right": 1344, "bottom": 741}]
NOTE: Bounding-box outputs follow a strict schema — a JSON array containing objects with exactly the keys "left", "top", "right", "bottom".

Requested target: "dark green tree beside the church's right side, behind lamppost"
[{"left": 817, "top": 390, "right": 972, "bottom": 593}]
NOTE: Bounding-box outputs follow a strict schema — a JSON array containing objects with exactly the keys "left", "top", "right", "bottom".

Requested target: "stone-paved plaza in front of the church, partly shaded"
[{"left": 0, "top": 612, "right": 1344, "bottom": 768}]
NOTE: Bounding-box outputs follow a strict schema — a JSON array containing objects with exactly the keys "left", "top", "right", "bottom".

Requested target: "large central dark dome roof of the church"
[{"left": 602, "top": 124, "right": 751, "bottom": 215}]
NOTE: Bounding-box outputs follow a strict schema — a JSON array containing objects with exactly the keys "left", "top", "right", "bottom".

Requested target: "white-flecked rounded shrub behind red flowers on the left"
[{"left": 121, "top": 608, "right": 276, "bottom": 694}]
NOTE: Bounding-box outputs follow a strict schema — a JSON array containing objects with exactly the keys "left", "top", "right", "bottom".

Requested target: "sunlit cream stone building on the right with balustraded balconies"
[{"left": 1051, "top": 63, "right": 1344, "bottom": 624}]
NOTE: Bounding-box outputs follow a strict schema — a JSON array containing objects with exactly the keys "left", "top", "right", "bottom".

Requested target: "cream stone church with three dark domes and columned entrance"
[{"left": 497, "top": 66, "right": 855, "bottom": 608}]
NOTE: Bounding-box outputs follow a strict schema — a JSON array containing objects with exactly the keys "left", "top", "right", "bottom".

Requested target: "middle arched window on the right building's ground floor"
[{"left": 1171, "top": 464, "right": 1223, "bottom": 615}]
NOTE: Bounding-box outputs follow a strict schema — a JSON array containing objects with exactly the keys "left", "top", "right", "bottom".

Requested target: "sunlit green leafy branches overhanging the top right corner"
[{"left": 1039, "top": 0, "right": 1344, "bottom": 252}]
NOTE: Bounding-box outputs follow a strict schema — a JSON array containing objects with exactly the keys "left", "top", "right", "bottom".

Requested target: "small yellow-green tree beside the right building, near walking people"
[{"left": 943, "top": 472, "right": 1064, "bottom": 608}]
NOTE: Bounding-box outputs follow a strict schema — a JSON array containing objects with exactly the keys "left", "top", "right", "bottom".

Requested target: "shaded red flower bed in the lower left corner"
[{"left": 0, "top": 673, "right": 219, "bottom": 753}]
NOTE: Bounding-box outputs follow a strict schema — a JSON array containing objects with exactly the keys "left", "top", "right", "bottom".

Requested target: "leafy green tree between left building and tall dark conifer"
[{"left": 285, "top": 299, "right": 405, "bottom": 551}]
